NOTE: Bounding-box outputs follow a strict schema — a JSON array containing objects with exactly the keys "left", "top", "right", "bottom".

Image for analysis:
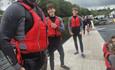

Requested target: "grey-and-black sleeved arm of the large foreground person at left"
[{"left": 0, "top": 4, "right": 25, "bottom": 70}]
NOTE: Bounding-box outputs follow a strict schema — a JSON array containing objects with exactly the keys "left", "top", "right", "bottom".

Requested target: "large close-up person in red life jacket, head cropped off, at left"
[{"left": 0, "top": 0, "right": 47, "bottom": 70}]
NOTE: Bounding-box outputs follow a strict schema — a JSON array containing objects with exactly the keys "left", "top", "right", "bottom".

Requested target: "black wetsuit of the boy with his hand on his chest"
[{"left": 48, "top": 16, "right": 64, "bottom": 70}]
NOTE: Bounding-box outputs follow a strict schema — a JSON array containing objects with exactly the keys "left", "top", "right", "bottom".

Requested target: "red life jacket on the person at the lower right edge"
[{"left": 103, "top": 43, "right": 111, "bottom": 68}]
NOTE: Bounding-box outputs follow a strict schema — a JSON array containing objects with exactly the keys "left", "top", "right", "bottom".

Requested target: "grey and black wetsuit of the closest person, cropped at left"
[{"left": 0, "top": 0, "right": 46, "bottom": 70}]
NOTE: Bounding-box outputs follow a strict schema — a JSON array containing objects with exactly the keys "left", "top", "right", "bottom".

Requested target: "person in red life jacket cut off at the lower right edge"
[{"left": 103, "top": 36, "right": 115, "bottom": 70}]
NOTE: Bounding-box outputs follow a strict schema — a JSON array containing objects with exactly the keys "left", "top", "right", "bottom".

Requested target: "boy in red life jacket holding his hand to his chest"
[{"left": 47, "top": 3, "right": 69, "bottom": 70}]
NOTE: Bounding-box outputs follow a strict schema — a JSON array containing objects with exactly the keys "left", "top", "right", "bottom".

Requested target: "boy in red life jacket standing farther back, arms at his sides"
[{"left": 68, "top": 6, "right": 85, "bottom": 58}]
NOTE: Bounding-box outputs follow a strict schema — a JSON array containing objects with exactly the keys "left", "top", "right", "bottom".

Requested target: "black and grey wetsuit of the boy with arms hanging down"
[{"left": 68, "top": 16, "right": 84, "bottom": 53}]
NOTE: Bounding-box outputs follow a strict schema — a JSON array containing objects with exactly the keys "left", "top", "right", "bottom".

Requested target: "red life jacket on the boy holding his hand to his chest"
[{"left": 47, "top": 16, "right": 61, "bottom": 37}]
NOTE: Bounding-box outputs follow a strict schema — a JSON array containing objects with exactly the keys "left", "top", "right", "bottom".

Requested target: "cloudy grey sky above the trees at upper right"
[{"left": 67, "top": 0, "right": 115, "bottom": 9}]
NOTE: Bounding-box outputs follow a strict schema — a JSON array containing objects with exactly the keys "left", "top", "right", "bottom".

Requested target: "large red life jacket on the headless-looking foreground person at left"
[{"left": 15, "top": 2, "right": 47, "bottom": 63}]
